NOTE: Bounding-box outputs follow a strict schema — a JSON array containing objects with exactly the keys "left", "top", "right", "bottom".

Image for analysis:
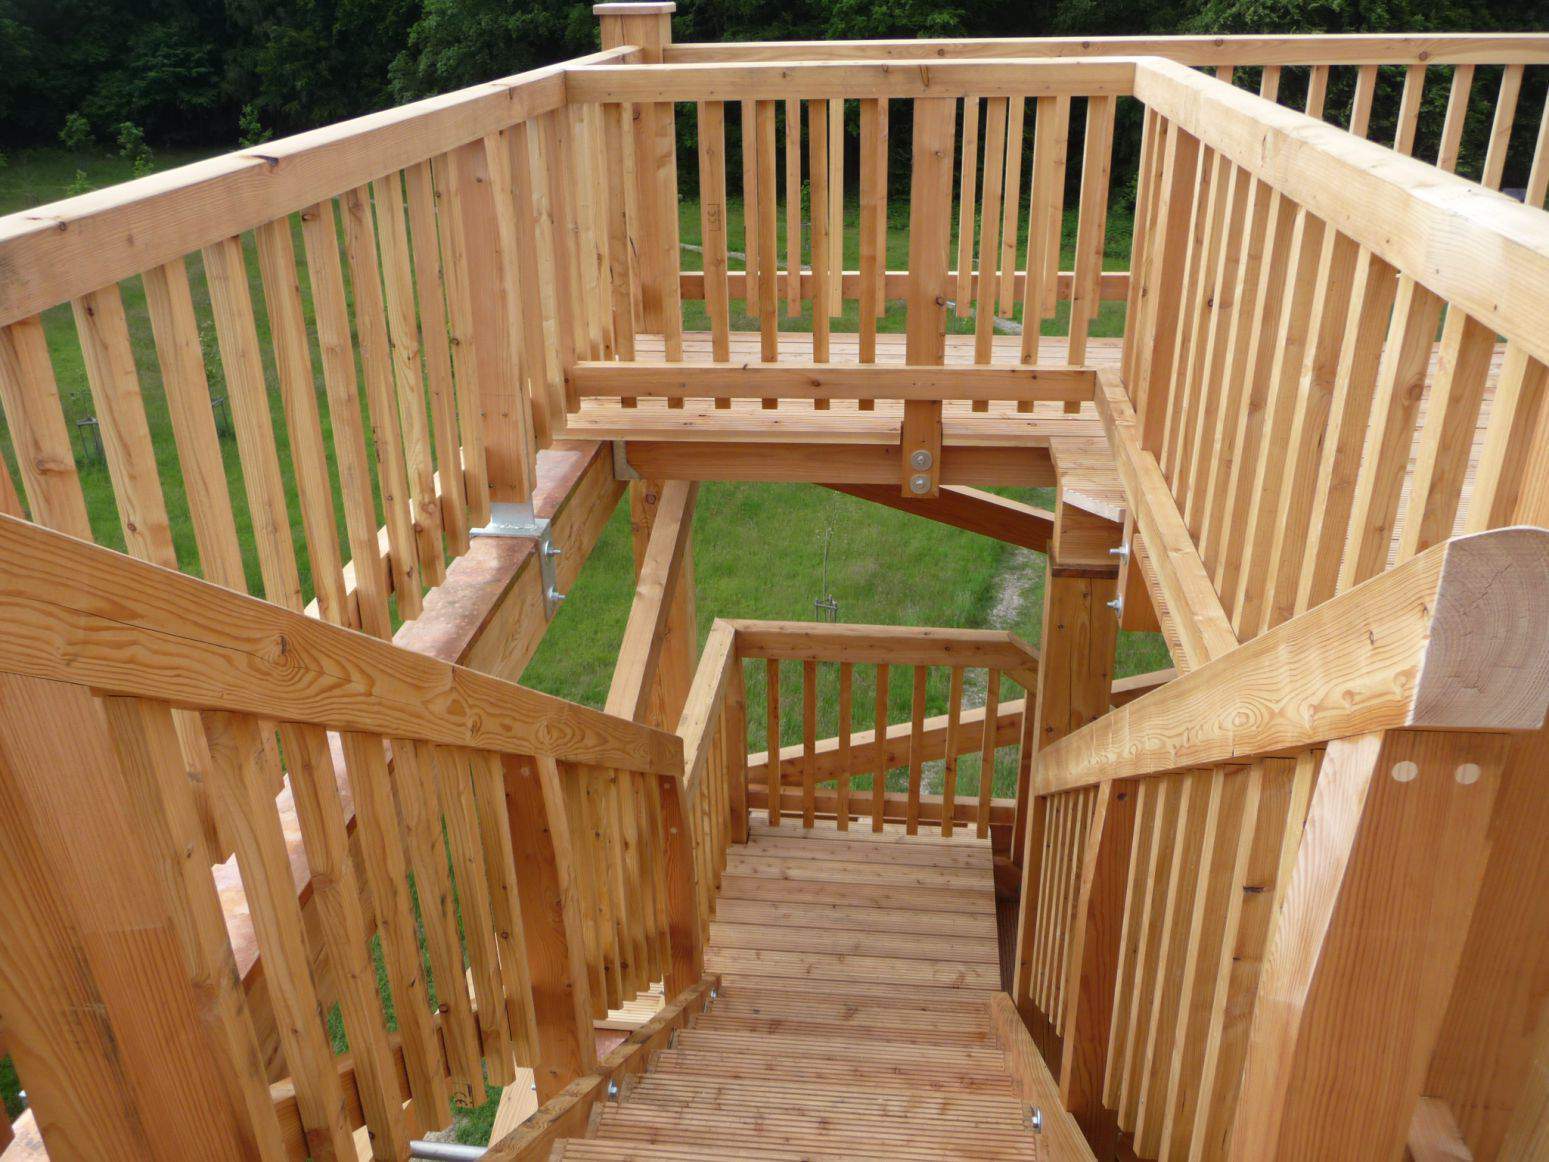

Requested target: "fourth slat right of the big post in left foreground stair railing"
[{"left": 339, "top": 733, "right": 452, "bottom": 1134}]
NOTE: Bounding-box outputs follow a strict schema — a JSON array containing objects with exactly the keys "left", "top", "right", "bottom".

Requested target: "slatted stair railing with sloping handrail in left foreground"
[{"left": 0, "top": 517, "right": 699, "bottom": 1157}]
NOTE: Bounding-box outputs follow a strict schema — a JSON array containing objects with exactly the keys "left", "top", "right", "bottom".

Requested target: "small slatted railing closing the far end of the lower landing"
[{"left": 730, "top": 621, "right": 1038, "bottom": 851}]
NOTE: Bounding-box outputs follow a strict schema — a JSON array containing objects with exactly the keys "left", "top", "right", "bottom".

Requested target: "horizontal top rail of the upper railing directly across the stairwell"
[{"left": 565, "top": 57, "right": 1135, "bottom": 104}]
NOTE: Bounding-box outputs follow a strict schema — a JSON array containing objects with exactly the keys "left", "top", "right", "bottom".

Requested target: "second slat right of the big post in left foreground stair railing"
[{"left": 203, "top": 713, "right": 355, "bottom": 1157}]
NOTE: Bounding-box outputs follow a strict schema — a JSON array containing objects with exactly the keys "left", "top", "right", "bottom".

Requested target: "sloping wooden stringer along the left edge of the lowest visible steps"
[{"left": 485, "top": 975, "right": 720, "bottom": 1162}]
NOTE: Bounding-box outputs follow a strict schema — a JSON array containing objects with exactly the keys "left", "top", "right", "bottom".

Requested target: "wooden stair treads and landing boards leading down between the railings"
[{"left": 551, "top": 823, "right": 1090, "bottom": 1159}]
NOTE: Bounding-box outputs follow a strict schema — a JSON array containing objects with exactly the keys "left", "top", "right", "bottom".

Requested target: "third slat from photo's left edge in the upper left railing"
[{"left": 141, "top": 259, "right": 248, "bottom": 593}]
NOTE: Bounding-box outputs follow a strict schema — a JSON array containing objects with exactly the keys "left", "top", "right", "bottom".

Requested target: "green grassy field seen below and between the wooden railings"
[{"left": 0, "top": 150, "right": 1166, "bottom": 1142}]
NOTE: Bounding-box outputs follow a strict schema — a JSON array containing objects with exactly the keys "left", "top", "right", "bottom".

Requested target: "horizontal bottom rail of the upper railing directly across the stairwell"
[{"left": 568, "top": 361, "right": 1097, "bottom": 403}]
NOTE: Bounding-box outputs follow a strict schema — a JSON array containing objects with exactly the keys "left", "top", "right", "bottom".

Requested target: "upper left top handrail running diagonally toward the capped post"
[{"left": 0, "top": 48, "right": 635, "bottom": 325}]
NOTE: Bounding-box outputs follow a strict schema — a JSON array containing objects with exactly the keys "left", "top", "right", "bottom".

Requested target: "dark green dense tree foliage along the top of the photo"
[{"left": 0, "top": 0, "right": 1549, "bottom": 149}]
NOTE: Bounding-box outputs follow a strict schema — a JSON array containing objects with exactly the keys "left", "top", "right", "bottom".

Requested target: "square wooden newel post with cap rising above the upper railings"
[{"left": 592, "top": 2, "right": 683, "bottom": 359}]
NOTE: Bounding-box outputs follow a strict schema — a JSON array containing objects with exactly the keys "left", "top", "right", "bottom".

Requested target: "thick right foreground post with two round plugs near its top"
[{"left": 1230, "top": 731, "right": 1509, "bottom": 1160}]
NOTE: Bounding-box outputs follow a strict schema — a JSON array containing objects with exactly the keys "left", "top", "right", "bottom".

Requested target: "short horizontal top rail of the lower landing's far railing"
[{"left": 731, "top": 621, "right": 1038, "bottom": 672}]
